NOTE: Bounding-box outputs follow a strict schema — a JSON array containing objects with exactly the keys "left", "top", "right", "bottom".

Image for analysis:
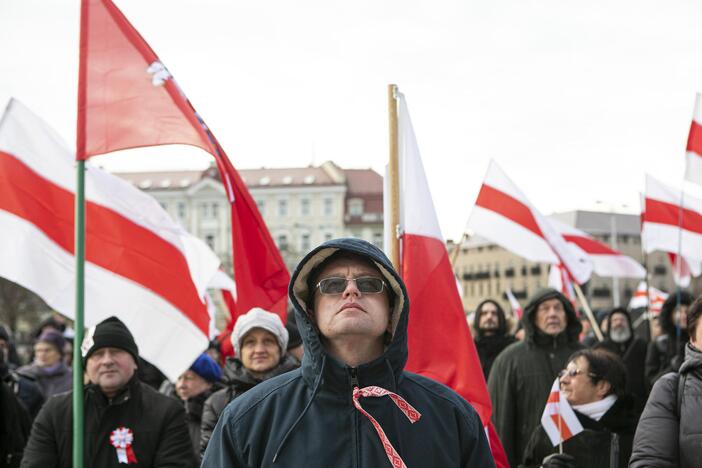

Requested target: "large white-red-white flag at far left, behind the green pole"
[{"left": 0, "top": 100, "right": 219, "bottom": 380}]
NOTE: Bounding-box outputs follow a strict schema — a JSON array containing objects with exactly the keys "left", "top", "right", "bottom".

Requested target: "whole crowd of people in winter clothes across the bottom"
[{"left": 0, "top": 239, "right": 702, "bottom": 468}]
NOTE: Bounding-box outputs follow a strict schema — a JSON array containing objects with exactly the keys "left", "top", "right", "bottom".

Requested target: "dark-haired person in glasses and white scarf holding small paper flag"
[{"left": 520, "top": 349, "right": 638, "bottom": 468}]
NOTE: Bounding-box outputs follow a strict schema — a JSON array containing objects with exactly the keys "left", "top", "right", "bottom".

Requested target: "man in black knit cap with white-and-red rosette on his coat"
[{"left": 21, "top": 317, "right": 197, "bottom": 468}]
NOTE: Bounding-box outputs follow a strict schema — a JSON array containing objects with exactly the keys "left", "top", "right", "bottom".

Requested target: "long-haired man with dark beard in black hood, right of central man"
[{"left": 473, "top": 299, "right": 517, "bottom": 381}]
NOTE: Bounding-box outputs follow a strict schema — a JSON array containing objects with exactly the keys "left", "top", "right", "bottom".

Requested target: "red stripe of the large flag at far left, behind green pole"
[{"left": 0, "top": 151, "right": 209, "bottom": 335}]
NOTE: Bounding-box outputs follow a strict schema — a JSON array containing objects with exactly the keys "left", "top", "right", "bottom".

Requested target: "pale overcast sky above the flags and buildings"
[{"left": 0, "top": 0, "right": 702, "bottom": 238}]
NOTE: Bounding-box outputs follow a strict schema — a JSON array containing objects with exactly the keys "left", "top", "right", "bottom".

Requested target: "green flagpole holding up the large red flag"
[{"left": 73, "top": 160, "right": 85, "bottom": 468}]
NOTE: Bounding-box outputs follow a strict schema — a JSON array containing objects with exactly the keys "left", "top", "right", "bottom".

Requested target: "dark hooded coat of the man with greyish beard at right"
[{"left": 594, "top": 309, "right": 649, "bottom": 414}]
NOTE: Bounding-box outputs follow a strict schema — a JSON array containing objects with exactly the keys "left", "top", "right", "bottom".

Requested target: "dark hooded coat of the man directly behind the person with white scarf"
[{"left": 488, "top": 289, "right": 583, "bottom": 466}]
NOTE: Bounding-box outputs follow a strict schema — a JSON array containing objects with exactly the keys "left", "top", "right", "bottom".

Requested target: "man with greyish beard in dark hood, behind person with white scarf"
[{"left": 595, "top": 307, "right": 648, "bottom": 414}]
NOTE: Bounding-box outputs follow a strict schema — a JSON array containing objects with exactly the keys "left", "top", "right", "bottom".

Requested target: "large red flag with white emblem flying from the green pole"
[{"left": 76, "top": 0, "right": 290, "bottom": 321}]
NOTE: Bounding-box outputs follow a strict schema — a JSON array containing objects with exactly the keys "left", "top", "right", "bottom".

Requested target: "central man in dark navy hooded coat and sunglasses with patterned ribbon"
[{"left": 202, "top": 239, "right": 494, "bottom": 468}]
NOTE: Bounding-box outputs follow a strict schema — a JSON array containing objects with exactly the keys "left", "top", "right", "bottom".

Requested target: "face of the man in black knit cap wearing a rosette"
[{"left": 85, "top": 347, "right": 137, "bottom": 398}]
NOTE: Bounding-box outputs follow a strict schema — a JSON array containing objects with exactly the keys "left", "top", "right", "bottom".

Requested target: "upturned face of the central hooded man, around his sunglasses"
[{"left": 313, "top": 258, "right": 390, "bottom": 342}]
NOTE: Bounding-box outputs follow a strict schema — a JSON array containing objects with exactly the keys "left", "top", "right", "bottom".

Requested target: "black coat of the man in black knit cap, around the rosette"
[{"left": 22, "top": 376, "right": 197, "bottom": 468}]
